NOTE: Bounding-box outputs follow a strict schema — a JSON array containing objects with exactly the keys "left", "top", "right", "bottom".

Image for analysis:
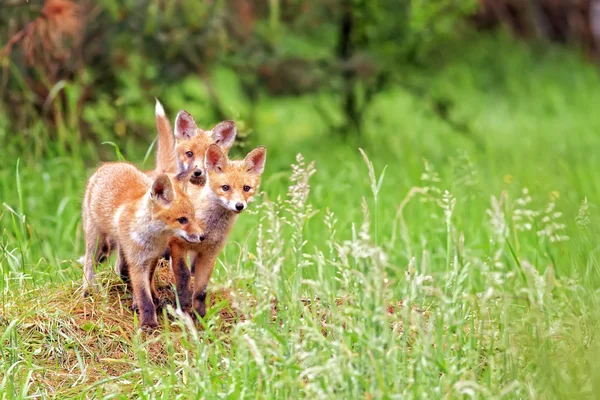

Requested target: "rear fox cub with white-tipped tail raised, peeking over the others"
[{"left": 149, "top": 100, "right": 237, "bottom": 181}]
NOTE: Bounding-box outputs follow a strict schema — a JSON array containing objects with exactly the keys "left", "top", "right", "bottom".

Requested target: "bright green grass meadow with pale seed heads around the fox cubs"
[{"left": 0, "top": 38, "right": 600, "bottom": 399}]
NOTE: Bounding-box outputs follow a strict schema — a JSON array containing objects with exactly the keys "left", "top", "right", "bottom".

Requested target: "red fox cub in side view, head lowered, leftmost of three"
[{"left": 82, "top": 162, "right": 205, "bottom": 327}]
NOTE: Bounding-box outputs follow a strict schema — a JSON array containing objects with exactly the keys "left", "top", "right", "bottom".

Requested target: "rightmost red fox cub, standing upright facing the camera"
[{"left": 170, "top": 144, "right": 267, "bottom": 317}]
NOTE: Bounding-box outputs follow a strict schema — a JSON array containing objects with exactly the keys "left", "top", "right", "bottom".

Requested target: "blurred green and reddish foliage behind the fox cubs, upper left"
[{"left": 0, "top": 0, "right": 477, "bottom": 150}]
